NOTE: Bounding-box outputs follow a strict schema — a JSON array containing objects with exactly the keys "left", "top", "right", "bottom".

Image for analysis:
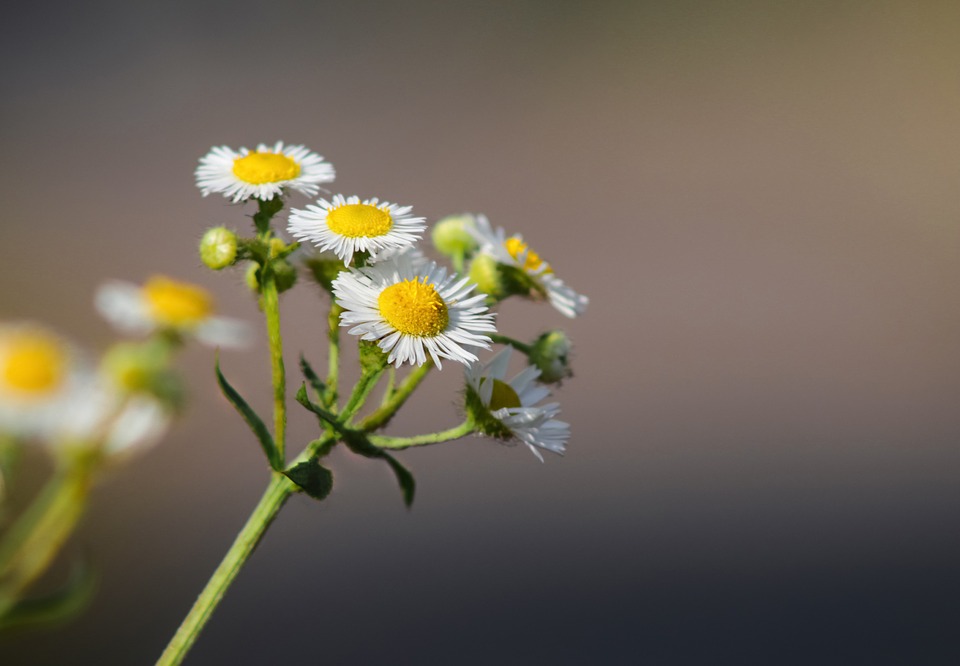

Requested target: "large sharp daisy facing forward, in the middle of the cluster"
[{"left": 333, "top": 255, "right": 497, "bottom": 368}]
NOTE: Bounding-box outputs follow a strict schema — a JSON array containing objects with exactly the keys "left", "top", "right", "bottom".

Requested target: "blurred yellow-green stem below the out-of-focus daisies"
[{"left": 0, "top": 457, "right": 95, "bottom": 617}]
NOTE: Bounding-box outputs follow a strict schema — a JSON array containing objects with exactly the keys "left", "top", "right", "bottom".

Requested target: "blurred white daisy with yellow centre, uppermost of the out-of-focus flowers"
[{"left": 96, "top": 275, "right": 249, "bottom": 347}]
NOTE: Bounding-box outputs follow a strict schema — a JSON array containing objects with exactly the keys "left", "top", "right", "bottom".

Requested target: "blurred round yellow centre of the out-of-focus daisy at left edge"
[{"left": 0, "top": 333, "right": 67, "bottom": 396}]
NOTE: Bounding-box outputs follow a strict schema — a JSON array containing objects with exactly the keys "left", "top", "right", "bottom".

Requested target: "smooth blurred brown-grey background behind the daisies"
[{"left": 0, "top": 0, "right": 960, "bottom": 664}]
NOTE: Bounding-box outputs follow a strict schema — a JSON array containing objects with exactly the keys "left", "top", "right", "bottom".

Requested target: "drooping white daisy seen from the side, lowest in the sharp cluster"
[{"left": 466, "top": 347, "right": 570, "bottom": 462}]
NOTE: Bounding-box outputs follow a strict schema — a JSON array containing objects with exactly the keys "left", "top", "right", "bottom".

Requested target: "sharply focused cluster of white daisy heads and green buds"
[{"left": 196, "top": 142, "right": 588, "bottom": 457}]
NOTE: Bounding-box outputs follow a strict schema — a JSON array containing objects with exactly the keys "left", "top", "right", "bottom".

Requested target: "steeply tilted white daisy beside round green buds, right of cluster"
[{"left": 472, "top": 215, "right": 590, "bottom": 317}]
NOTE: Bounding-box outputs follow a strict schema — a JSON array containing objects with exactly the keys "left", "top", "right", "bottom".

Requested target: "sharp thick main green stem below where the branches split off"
[{"left": 157, "top": 472, "right": 297, "bottom": 666}]
